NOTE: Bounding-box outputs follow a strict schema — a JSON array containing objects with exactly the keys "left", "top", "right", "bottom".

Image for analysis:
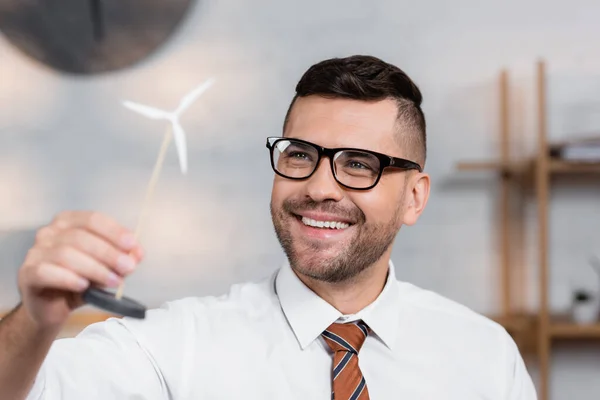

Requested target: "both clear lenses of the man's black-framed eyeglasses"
[{"left": 273, "top": 140, "right": 380, "bottom": 189}]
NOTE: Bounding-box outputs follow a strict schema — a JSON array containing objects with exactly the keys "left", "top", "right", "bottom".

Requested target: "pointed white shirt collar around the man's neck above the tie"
[{"left": 275, "top": 261, "right": 400, "bottom": 349}]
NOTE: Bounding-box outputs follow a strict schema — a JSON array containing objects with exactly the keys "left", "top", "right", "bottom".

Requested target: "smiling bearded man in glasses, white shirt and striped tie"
[{"left": 0, "top": 56, "right": 536, "bottom": 400}]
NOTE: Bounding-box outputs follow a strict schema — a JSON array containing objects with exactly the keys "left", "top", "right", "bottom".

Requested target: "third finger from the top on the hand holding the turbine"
[{"left": 45, "top": 246, "right": 122, "bottom": 287}]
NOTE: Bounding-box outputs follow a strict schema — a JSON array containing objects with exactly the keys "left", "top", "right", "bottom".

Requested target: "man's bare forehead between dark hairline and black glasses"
[{"left": 284, "top": 96, "right": 398, "bottom": 154}]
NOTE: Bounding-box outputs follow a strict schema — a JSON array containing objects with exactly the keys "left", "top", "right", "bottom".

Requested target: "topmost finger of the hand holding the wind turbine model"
[{"left": 52, "top": 211, "right": 139, "bottom": 251}]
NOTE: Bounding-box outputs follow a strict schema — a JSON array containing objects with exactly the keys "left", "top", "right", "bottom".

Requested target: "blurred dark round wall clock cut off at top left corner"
[{"left": 0, "top": 0, "right": 195, "bottom": 74}]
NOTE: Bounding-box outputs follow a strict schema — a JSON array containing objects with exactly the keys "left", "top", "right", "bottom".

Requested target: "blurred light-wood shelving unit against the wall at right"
[{"left": 456, "top": 61, "right": 600, "bottom": 400}]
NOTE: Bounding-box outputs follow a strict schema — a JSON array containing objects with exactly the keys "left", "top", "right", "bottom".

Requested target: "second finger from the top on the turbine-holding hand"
[{"left": 55, "top": 229, "right": 139, "bottom": 276}]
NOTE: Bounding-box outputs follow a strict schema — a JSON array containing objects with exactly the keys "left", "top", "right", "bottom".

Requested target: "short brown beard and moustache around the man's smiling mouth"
[{"left": 271, "top": 199, "right": 401, "bottom": 283}]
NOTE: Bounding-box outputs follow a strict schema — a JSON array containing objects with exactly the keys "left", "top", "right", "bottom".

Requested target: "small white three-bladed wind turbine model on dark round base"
[{"left": 83, "top": 78, "right": 214, "bottom": 318}]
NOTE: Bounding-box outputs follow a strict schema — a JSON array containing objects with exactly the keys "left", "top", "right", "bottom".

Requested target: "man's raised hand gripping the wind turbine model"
[{"left": 18, "top": 211, "right": 143, "bottom": 329}]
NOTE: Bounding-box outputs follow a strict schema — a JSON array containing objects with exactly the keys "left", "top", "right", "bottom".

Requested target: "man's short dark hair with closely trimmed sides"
[{"left": 283, "top": 55, "right": 427, "bottom": 167}]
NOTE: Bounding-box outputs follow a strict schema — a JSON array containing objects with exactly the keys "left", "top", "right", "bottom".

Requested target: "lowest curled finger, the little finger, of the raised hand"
[{"left": 28, "top": 263, "right": 90, "bottom": 292}]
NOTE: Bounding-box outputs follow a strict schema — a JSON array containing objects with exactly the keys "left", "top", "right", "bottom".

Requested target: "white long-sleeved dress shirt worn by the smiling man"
[{"left": 28, "top": 263, "right": 536, "bottom": 400}]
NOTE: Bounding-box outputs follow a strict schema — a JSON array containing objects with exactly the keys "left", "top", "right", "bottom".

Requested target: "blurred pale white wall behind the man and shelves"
[{"left": 0, "top": 0, "right": 600, "bottom": 400}]
